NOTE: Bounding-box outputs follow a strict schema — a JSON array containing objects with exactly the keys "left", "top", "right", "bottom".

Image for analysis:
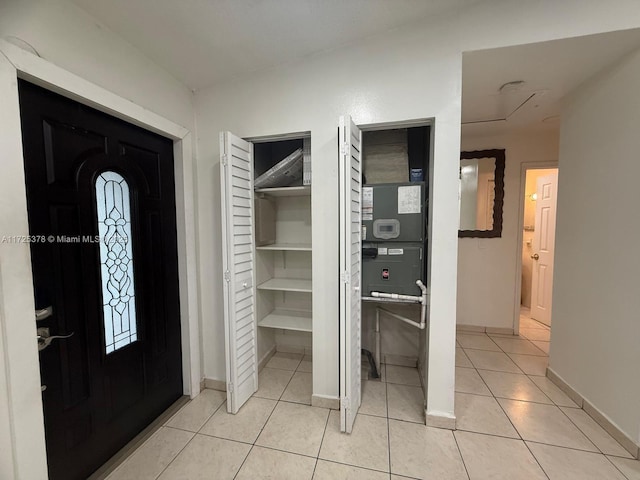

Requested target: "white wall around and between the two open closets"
[{"left": 196, "top": 6, "right": 460, "bottom": 411}]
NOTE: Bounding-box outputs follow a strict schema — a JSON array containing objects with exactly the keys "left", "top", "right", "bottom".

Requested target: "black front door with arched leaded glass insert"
[{"left": 19, "top": 81, "right": 182, "bottom": 480}]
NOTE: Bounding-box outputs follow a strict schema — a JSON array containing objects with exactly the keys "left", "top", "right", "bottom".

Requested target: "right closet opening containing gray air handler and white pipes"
[{"left": 360, "top": 121, "right": 432, "bottom": 423}]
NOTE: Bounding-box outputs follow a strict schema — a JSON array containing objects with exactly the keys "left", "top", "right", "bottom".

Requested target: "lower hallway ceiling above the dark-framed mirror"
[{"left": 462, "top": 29, "right": 640, "bottom": 135}]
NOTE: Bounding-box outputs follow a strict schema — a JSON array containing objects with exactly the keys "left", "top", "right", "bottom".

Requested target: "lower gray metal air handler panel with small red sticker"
[{"left": 362, "top": 242, "right": 426, "bottom": 296}]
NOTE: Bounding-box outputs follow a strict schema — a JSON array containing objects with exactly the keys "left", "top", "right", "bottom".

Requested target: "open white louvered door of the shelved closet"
[{"left": 220, "top": 132, "right": 258, "bottom": 413}]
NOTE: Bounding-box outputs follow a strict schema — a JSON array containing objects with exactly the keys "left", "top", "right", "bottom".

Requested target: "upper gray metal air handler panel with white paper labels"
[{"left": 362, "top": 182, "right": 426, "bottom": 242}]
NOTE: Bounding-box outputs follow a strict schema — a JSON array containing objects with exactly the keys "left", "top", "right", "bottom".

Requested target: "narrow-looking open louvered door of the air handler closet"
[{"left": 338, "top": 116, "right": 362, "bottom": 433}]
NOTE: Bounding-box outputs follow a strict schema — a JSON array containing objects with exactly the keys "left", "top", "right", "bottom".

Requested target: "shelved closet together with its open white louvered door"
[{"left": 220, "top": 132, "right": 313, "bottom": 413}]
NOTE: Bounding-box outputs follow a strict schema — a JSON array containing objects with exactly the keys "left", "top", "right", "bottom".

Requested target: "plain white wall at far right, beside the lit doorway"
[{"left": 550, "top": 47, "right": 640, "bottom": 443}]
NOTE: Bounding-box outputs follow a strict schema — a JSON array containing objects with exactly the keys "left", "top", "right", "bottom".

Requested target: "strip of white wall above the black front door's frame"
[{"left": 0, "top": 0, "right": 194, "bottom": 131}]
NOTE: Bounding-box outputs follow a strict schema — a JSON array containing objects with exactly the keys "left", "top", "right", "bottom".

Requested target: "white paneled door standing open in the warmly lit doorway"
[{"left": 531, "top": 173, "right": 558, "bottom": 325}]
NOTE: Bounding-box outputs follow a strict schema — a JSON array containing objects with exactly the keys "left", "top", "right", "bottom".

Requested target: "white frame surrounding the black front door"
[{"left": 0, "top": 40, "right": 201, "bottom": 478}]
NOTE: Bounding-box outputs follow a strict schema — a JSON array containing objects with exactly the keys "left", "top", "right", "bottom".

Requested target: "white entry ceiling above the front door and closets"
[{"left": 72, "top": 0, "right": 477, "bottom": 90}]
